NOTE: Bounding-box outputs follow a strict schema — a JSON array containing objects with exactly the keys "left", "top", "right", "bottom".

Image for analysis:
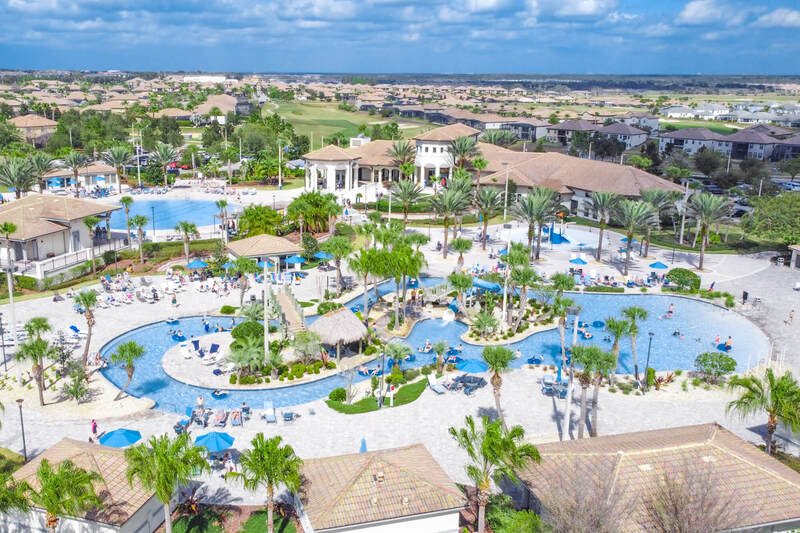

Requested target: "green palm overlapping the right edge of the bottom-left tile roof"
[{"left": 125, "top": 433, "right": 210, "bottom": 533}]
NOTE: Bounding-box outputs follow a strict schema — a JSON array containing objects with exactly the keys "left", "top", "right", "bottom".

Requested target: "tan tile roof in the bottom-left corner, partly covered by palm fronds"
[{"left": 14, "top": 438, "right": 155, "bottom": 526}]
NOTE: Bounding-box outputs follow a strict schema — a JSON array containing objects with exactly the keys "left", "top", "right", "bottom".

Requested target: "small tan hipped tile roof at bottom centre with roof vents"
[{"left": 300, "top": 444, "right": 466, "bottom": 530}]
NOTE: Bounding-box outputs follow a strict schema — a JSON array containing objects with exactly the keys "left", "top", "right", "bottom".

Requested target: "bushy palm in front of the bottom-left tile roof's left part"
[{"left": 28, "top": 459, "right": 103, "bottom": 533}]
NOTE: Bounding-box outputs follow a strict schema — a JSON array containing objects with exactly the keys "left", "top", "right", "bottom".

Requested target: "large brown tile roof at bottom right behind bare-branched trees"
[{"left": 520, "top": 424, "right": 800, "bottom": 533}]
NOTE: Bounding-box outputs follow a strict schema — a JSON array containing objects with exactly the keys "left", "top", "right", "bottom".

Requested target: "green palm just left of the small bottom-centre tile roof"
[{"left": 225, "top": 433, "right": 303, "bottom": 533}]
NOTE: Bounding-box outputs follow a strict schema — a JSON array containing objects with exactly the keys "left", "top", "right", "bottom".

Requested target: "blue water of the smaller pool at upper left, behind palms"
[{"left": 105, "top": 197, "right": 235, "bottom": 230}]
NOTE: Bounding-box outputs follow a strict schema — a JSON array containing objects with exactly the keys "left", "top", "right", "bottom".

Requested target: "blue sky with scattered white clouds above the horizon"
[{"left": 0, "top": 0, "right": 800, "bottom": 74}]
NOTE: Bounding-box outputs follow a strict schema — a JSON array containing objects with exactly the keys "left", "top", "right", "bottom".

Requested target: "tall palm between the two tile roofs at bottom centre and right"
[{"left": 449, "top": 416, "right": 542, "bottom": 533}]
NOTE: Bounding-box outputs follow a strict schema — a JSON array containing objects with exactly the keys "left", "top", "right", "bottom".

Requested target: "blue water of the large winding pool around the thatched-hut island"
[{"left": 101, "top": 278, "right": 769, "bottom": 413}]
